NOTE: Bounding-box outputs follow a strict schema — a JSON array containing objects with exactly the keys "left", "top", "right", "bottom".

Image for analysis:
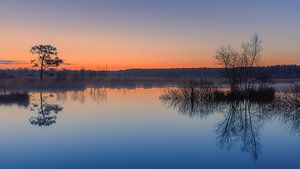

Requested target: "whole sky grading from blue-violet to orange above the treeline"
[{"left": 0, "top": 0, "right": 300, "bottom": 70}]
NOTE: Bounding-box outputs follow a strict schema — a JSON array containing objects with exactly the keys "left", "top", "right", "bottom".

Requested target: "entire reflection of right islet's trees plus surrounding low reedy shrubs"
[{"left": 160, "top": 88, "right": 300, "bottom": 160}]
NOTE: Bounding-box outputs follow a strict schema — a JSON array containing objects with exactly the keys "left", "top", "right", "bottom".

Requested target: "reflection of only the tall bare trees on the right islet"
[{"left": 216, "top": 101, "right": 262, "bottom": 160}]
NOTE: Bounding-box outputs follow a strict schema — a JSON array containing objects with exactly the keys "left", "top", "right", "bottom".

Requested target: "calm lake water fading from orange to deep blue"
[{"left": 0, "top": 88, "right": 300, "bottom": 169}]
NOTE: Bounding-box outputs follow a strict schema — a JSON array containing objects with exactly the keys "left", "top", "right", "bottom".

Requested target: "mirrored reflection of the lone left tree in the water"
[{"left": 29, "top": 92, "right": 63, "bottom": 126}]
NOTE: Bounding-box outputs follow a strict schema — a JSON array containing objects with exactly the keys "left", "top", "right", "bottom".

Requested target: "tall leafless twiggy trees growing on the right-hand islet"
[{"left": 215, "top": 34, "right": 262, "bottom": 91}]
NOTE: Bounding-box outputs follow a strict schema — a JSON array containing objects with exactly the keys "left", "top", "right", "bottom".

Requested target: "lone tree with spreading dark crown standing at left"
[{"left": 30, "top": 45, "right": 63, "bottom": 81}]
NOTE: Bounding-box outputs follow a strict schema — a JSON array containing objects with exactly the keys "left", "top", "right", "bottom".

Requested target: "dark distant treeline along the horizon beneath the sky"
[{"left": 0, "top": 65, "right": 300, "bottom": 80}]
